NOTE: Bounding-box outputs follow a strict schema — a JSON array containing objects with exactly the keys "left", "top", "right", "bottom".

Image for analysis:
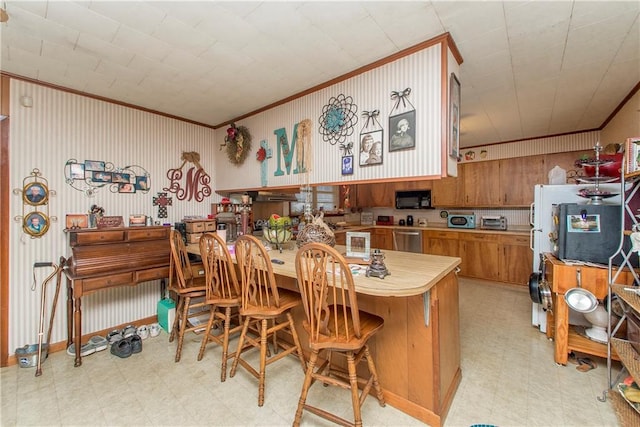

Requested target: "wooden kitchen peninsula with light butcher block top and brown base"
[{"left": 188, "top": 242, "right": 462, "bottom": 426}]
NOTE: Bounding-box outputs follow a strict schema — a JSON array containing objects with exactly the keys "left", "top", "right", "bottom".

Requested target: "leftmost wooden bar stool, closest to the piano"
[{"left": 169, "top": 230, "right": 209, "bottom": 362}]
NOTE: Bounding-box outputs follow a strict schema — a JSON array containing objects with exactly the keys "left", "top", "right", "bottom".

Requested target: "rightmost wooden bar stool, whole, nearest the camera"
[{"left": 293, "top": 243, "right": 385, "bottom": 426}]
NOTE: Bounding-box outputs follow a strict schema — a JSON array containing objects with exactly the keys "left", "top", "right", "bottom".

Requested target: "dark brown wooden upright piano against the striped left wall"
[{"left": 64, "top": 226, "right": 171, "bottom": 366}]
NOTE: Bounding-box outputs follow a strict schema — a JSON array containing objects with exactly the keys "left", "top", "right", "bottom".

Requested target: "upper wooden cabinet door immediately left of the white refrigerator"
[{"left": 499, "top": 155, "right": 546, "bottom": 206}]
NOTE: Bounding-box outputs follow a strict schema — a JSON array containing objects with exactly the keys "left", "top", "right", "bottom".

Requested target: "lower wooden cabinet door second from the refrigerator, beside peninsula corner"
[{"left": 459, "top": 233, "right": 500, "bottom": 280}]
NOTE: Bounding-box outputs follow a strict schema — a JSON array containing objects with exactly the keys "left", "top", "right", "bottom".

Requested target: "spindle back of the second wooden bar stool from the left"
[{"left": 199, "top": 233, "right": 240, "bottom": 301}]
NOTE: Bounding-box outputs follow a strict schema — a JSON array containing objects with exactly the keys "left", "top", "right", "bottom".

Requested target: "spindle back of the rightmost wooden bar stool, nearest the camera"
[{"left": 296, "top": 243, "right": 361, "bottom": 349}]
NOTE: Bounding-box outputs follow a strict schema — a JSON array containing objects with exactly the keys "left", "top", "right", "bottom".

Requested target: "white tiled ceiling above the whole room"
[{"left": 0, "top": 1, "right": 640, "bottom": 147}]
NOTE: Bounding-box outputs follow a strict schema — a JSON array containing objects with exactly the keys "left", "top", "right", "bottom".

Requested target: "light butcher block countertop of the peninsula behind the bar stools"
[{"left": 187, "top": 242, "right": 461, "bottom": 297}]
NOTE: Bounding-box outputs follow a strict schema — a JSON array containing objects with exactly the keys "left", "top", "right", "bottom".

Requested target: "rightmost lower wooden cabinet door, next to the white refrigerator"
[{"left": 500, "top": 236, "right": 533, "bottom": 286}]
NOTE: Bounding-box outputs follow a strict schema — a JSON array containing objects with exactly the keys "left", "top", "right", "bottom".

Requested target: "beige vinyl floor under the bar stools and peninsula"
[{"left": 0, "top": 278, "right": 618, "bottom": 427}]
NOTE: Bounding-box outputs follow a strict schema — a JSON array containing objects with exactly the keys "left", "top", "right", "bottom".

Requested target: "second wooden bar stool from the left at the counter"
[{"left": 198, "top": 233, "right": 242, "bottom": 382}]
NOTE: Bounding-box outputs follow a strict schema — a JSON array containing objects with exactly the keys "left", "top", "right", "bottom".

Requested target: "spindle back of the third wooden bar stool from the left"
[{"left": 235, "top": 234, "right": 280, "bottom": 316}]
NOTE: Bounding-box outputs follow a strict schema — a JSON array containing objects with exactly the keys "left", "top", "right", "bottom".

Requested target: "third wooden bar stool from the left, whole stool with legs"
[{"left": 229, "top": 234, "right": 306, "bottom": 406}]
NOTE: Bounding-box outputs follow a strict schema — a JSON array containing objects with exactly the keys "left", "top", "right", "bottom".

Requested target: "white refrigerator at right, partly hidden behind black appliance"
[{"left": 529, "top": 183, "right": 622, "bottom": 332}]
